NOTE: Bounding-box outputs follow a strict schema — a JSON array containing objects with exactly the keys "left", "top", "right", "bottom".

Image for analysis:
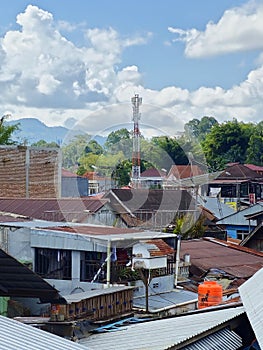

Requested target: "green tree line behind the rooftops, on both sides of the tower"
[{"left": 0, "top": 116, "right": 263, "bottom": 185}]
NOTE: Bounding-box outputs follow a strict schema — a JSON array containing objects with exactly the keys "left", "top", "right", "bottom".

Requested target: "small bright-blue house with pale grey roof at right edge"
[{"left": 217, "top": 202, "right": 263, "bottom": 240}]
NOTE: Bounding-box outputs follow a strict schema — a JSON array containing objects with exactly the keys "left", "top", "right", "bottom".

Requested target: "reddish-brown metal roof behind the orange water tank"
[{"left": 180, "top": 238, "right": 263, "bottom": 278}]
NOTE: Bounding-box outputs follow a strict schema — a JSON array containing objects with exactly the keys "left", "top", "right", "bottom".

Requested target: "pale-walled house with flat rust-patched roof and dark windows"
[{"left": 0, "top": 220, "right": 177, "bottom": 294}]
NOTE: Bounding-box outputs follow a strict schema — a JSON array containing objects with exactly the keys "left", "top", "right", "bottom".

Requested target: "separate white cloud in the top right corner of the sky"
[{"left": 168, "top": 2, "right": 263, "bottom": 58}]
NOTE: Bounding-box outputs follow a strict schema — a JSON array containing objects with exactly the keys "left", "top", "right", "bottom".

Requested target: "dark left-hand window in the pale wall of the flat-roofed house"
[{"left": 35, "top": 248, "right": 71, "bottom": 280}]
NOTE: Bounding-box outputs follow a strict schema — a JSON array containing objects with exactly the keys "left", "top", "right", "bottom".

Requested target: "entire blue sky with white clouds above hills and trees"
[{"left": 0, "top": 0, "right": 263, "bottom": 134}]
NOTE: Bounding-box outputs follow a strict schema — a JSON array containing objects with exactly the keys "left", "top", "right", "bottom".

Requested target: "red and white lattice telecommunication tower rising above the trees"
[{"left": 131, "top": 94, "right": 142, "bottom": 188}]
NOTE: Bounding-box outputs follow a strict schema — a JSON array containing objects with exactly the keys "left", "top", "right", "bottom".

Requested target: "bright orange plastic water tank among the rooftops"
[{"left": 198, "top": 281, "right": 223, "bottom": 309}]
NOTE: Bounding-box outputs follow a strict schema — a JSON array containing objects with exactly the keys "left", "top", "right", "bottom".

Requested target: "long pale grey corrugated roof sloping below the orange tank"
[{"left": 80, "top": 306, "right": 245, "bottom": 350}]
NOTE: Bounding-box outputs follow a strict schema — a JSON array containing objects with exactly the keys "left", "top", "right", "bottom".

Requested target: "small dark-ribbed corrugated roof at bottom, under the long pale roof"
[{"left": 184, "top": 328, "right": 243, "bottom": 350}]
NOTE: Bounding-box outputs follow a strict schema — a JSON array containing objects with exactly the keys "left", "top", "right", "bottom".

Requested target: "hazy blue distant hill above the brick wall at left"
[{"left": 6, "top": 118, "right": 106, "bottom": 145}]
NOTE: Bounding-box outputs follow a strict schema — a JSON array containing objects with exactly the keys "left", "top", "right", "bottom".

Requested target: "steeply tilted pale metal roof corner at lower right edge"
[{"left": 238, "top": 269, "right": 263, "bottom": 349}]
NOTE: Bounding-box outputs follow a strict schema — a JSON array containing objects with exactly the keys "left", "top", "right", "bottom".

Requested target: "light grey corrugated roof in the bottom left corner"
[{"left": 0, "top": 316, "right": 86, "bottom": 350}]
